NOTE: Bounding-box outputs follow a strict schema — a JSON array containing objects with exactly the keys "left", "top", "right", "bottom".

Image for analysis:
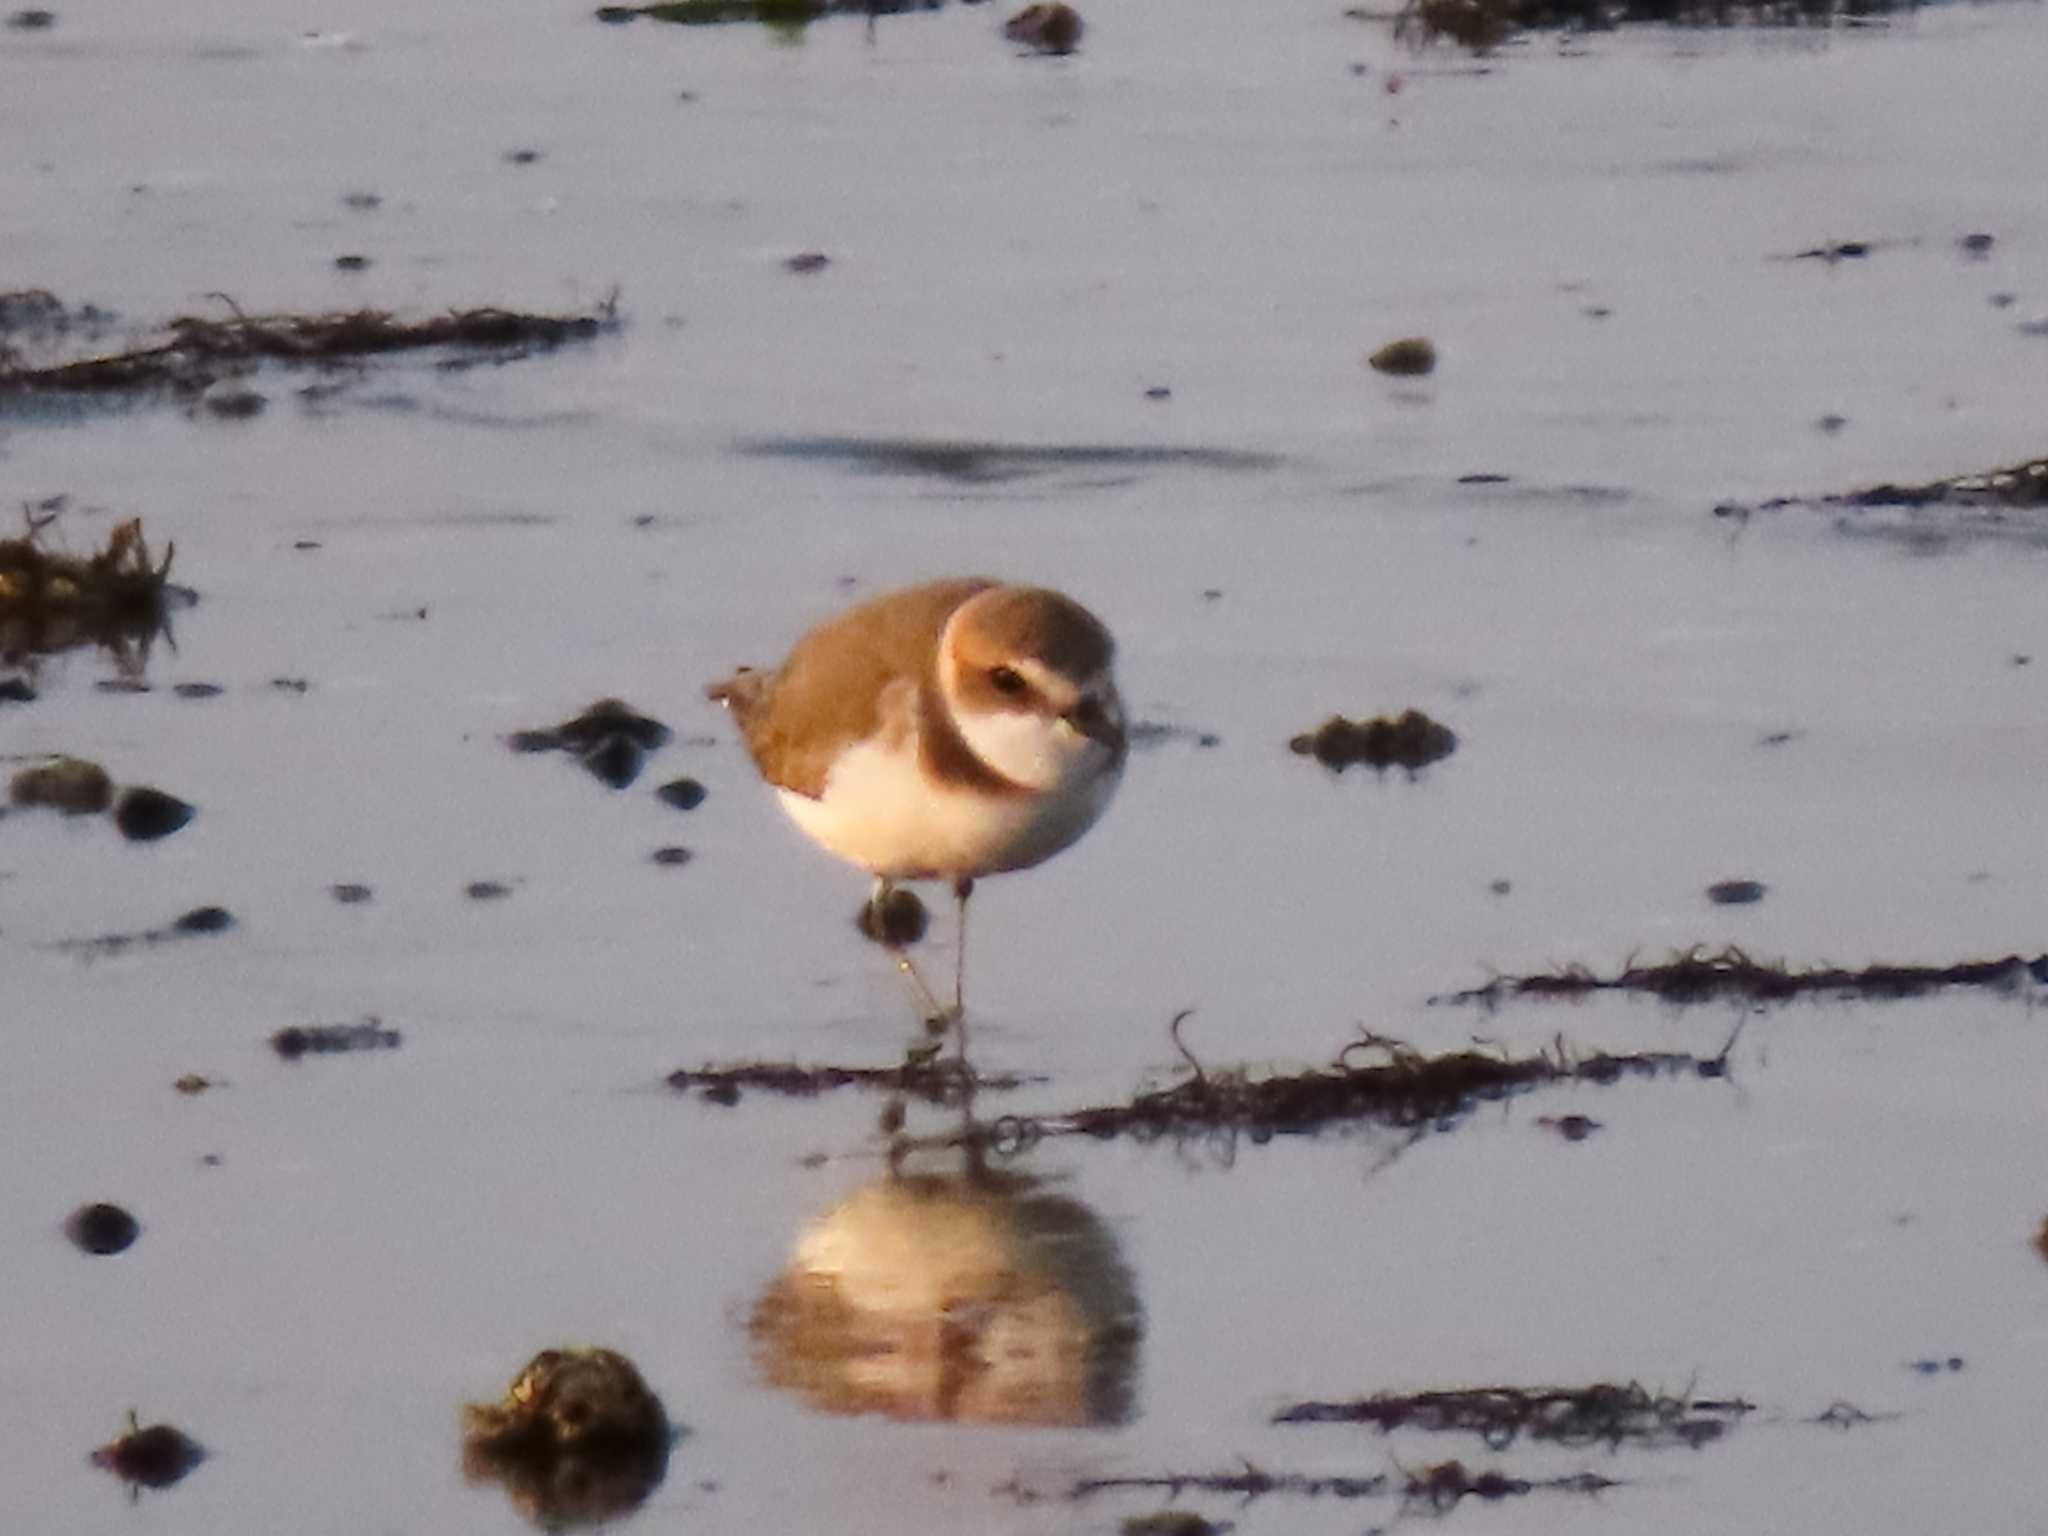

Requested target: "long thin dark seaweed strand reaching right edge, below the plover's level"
[{"left": 1430, "top": 946, "right": 2048, "bottom": 1008}]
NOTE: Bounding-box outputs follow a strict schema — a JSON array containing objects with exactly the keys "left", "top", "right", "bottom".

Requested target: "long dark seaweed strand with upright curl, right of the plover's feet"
[{"left": 899, "top": 1012, "right": 1741, "bottom": 1155}]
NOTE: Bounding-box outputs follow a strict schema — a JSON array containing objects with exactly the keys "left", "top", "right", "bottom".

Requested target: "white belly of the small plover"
[{"left": 780, "top": 743, "right": 1122, "bottom": 881}]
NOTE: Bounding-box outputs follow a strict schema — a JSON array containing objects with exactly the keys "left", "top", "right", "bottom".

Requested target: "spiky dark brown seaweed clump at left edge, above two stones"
[{"left": 0, "top": 514, "right": 178, "bottom": 664}]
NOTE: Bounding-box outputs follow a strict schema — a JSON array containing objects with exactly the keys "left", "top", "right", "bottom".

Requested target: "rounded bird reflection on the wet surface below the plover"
[{"left": 750, "top": 1169, "right": 1143, "bottom": 1425}]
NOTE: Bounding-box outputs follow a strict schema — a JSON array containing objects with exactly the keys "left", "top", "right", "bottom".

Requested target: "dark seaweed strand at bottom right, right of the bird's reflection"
[{"left": 1272, "top": 1382, "right": 1757, "bottom": 1450}]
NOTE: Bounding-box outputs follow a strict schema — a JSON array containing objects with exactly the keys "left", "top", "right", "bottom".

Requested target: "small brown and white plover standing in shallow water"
[{"left": 707, "top": 580, "right": 1124, "bottom": 1022}]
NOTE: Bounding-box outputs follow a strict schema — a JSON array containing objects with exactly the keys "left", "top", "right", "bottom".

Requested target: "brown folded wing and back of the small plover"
[{"left": 707, "top": 580, "right": 993, "bottom": 797}]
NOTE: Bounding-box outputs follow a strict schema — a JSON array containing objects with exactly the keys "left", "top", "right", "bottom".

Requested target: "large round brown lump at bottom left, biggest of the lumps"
[{"left": 463, "top": 1350, "right": 678, "bottom": 1532}]
